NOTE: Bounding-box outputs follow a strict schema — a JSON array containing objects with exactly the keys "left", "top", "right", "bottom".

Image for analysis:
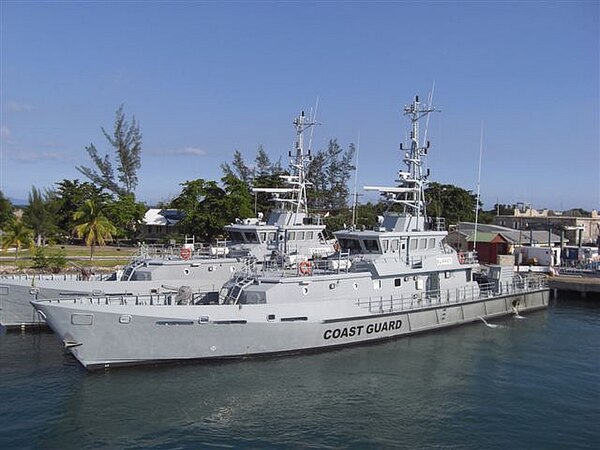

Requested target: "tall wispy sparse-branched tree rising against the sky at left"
[{"left": 77, "top": 105, "right": 142, "bottom": 196}]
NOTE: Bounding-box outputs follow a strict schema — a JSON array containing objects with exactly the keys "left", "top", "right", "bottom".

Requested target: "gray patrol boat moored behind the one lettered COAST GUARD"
[{"left": 0, "top": 112, "right": 335, "bottom": 328}]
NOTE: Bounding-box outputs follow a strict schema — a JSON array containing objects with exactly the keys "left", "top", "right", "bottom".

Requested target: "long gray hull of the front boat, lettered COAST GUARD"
[{"left": 33, "top": 289, "right": 549, "bottom": 370}]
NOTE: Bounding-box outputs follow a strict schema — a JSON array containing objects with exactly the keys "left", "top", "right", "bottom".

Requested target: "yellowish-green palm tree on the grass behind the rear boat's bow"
[{"left": 73, "top": 199, "right": 117, "bottom": 260}]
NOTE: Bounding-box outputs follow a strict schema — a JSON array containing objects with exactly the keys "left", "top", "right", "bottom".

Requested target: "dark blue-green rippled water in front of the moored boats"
[{"left": 0, "top": 294, "right": 600, "bottom": 449}]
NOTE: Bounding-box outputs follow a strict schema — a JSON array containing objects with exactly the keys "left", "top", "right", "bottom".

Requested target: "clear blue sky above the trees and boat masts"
[{"left": 0, "top": 0, "right": 600, "bottom": 210}]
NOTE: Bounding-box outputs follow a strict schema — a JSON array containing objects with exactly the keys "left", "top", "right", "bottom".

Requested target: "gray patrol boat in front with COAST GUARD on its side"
[{"left": 32, "top": 99, "right": 549, "bottom": 369}]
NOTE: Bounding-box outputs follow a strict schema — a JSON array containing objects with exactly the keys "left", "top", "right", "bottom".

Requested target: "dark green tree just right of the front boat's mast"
[{"left": 425, "top": 183, "right": 477, "bottom": 226}]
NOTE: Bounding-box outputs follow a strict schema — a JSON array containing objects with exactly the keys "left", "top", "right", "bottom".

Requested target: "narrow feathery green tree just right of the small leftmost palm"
[{"left": 23, "top": 186, "right": 58, "bottom": 247}]
